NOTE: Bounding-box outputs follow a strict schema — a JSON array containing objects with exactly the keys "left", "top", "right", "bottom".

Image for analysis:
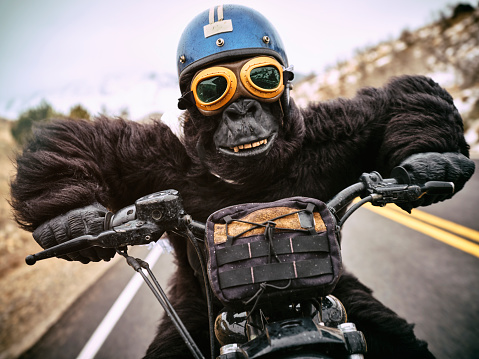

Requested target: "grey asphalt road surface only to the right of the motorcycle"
[{"left": 342, "top": 161, "right": 479, "bottom": 359}]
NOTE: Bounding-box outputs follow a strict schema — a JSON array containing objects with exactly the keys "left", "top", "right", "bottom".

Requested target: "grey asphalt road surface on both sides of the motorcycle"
[{"left": 16, "top": 161, "right": 479, "bottom": 359}]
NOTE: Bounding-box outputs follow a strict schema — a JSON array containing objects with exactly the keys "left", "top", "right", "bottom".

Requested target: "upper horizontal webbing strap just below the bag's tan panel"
[{"left": 216, "top": 232, "right": 329, "bottom": 266}]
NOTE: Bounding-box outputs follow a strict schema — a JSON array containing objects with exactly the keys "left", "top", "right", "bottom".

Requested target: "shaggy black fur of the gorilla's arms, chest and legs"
[{"left": 12, "top": 76, "right": 468, "bottom": 358}]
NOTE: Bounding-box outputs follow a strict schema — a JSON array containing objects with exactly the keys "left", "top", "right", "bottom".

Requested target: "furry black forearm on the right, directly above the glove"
[{"left": 379, "top": 76, "right": 469, "bottom": 167}]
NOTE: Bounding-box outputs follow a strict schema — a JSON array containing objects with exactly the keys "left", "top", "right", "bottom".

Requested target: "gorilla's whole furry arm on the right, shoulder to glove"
[{"left": 304, "top": 76, "right": 469, "bottom": 193}]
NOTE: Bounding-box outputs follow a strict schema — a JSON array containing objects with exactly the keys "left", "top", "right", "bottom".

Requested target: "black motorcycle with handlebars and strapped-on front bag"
[{"left": 26, "top": 167, "right": 454, "bottom": 359}]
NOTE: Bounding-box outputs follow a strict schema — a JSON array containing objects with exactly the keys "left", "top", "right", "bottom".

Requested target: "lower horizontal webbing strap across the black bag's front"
[{"left": 219, "top": 258, "right": 333, "bottom": 289}]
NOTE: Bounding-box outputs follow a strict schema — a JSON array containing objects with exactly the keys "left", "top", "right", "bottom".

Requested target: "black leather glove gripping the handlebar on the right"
[{"left": 398, "top": 152, "right": 475, "bottom": 213}]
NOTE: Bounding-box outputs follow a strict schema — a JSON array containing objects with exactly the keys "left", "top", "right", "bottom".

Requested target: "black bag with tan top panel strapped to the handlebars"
[{"left": 206, "top": 197, "right": 342, "bottom": 308}]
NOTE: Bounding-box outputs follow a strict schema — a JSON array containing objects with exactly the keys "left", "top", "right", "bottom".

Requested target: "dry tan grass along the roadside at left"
[{"left": 0, "top": 119, "right": 112, "bottom": 359}]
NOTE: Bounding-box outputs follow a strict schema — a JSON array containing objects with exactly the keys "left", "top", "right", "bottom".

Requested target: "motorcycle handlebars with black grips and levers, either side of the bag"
[{"left": 25, "top": 167, "right": 454, "bottom": 265}]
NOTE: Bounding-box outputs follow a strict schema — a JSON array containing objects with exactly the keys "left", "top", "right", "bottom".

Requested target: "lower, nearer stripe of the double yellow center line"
[{"left": 364, "top": 203, "right": 479, "bottom": 258}]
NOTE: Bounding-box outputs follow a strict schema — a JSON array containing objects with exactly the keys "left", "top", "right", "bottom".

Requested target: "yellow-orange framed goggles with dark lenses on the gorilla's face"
[{"left": 178, "top": 56, "right": 293, "bottom": 116}]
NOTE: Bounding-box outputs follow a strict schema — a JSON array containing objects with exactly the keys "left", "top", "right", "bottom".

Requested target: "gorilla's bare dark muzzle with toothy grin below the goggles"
[{"left": 213, "top": 98, "right": 280, "bottom": 159}]
